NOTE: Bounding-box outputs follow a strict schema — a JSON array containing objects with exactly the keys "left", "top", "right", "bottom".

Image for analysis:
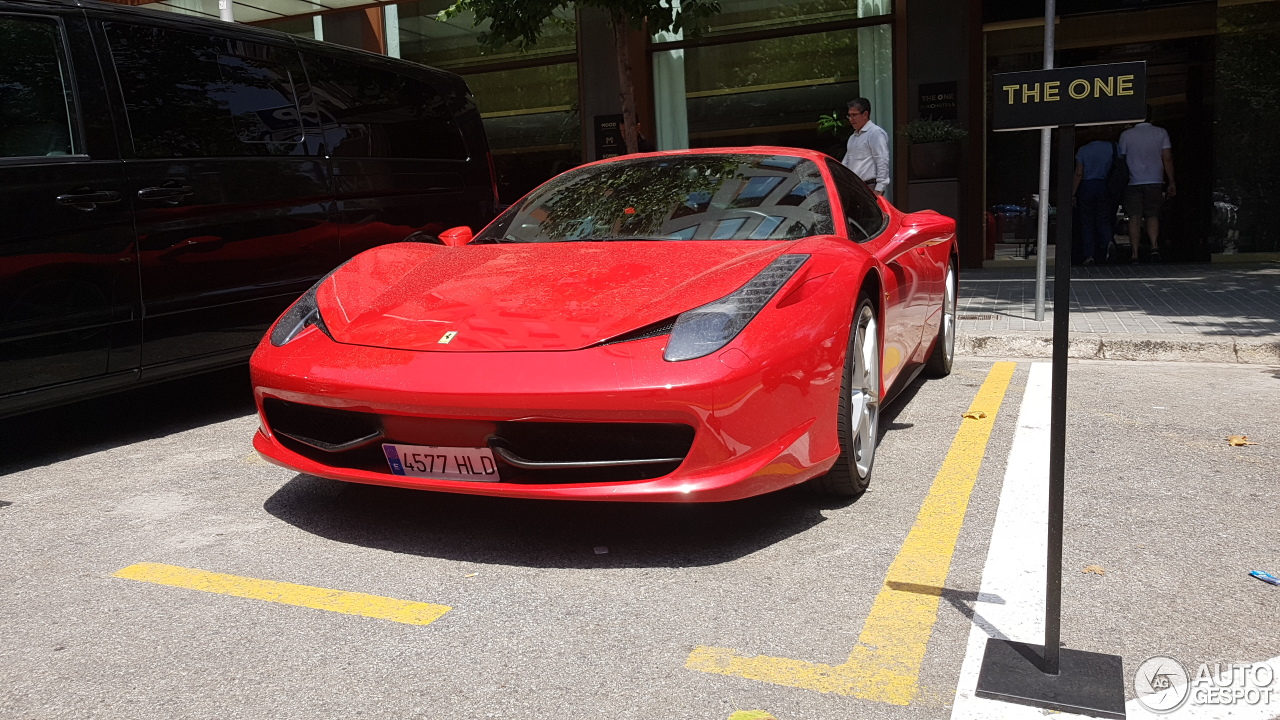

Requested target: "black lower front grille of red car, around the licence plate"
[{"left": 262, "top": 398, "right": 695, "bottom": 483}]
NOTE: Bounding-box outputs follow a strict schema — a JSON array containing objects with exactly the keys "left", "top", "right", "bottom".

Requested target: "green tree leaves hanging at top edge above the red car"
[{"left": 438, "top": 0, "right": 721, "bottom": 47}]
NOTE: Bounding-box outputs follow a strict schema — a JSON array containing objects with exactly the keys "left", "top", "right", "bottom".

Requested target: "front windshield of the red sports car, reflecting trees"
[{"left": 472, "top": 155, "right": 833, "bottom": 243}]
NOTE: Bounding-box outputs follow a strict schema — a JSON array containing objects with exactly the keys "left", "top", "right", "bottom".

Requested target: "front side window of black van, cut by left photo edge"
[{"left": 0, "top": 15, "right": 77, "bottom": 158}]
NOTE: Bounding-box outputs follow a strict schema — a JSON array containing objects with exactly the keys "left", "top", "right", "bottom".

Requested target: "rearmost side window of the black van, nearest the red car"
[{"left": 303, "top": 55, "right": 467, "bottom": 160}]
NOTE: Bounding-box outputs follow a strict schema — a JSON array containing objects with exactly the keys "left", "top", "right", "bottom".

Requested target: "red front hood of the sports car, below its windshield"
[{"left": 317, "top": 241, "right": 795, "bottom": 352}]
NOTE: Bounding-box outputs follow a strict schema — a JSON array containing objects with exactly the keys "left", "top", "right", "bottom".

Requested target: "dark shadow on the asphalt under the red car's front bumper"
[{"left": 262, "top": 474, "right": 854, "bottom": 569}]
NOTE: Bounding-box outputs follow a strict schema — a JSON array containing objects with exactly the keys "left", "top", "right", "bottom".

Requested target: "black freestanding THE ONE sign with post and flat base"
[{"left": 977, "top": 63, "right": 1147, "bottom": 720}]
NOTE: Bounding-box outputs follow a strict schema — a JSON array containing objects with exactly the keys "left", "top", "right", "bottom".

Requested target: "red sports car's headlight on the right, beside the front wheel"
[{"left": 662, "top": 255, "right": 809, "bottom": 363}]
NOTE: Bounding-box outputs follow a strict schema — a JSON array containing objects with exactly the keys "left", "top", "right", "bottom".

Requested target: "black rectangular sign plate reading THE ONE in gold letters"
[{"left": 991, "top": 63, "right": 1147, "bottom": 131}]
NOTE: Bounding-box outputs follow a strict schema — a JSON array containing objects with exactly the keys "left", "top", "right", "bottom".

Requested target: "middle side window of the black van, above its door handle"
[{"left": 106, "top": 23, "right": 305, "bottom": 158}]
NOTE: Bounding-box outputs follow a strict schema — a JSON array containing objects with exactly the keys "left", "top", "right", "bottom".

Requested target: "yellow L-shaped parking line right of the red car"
[{"left": 685, "top": 363, "right": 1018, "bottom": 705}]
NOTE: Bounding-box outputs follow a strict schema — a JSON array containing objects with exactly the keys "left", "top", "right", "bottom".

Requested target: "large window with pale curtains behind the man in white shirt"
[{"left": 653, "top": 0, "right": 893, "bottom": 170}]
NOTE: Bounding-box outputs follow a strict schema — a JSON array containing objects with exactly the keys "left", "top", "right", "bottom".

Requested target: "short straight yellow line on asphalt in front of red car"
[{"left": 114, "top": 562, "right": 452, "bottom": 625}]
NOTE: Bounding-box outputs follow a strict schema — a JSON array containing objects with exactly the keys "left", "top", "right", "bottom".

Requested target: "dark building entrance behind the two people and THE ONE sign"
[{"left": 984, "top": 0, "right": 1280, "bottom": 263}]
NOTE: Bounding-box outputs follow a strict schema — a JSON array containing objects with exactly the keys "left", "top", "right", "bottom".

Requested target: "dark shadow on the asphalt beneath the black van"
[{"left": 0, "top": 365, "right": 256, "bottom": 475}]
